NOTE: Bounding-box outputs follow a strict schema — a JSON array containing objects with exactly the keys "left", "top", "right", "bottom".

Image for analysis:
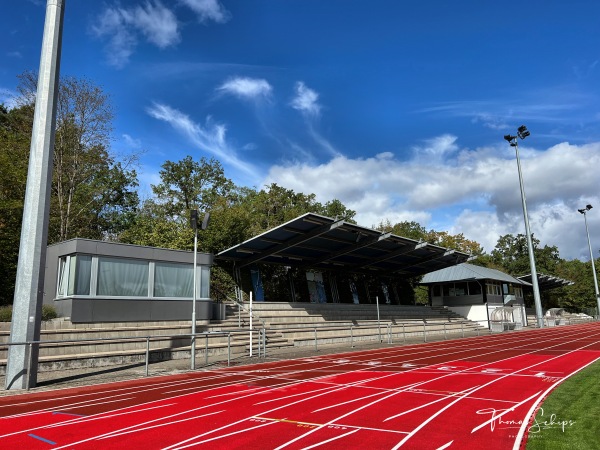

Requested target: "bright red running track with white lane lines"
[{"left": 0, "top": 323, "right": 600, "bottom": 450}]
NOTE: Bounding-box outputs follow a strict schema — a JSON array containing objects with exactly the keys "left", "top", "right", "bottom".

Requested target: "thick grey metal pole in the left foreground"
[{"left": 5, "top": 0, "right": 65, "bottom": 389}]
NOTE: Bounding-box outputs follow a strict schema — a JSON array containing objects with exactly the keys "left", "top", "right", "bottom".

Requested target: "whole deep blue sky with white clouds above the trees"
[{"left": 0, "top": 0, "right": 600, "bottom": 260}]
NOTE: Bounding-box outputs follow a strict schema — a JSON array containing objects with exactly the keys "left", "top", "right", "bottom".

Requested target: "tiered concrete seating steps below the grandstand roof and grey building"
[{"left": 0, "top": 302, "right": 478, "bottom": 373}]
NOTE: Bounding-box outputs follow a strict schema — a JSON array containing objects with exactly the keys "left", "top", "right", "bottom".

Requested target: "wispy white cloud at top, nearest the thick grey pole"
[{"left": 92, "top": 0, "right": 180, "bottom": 68}]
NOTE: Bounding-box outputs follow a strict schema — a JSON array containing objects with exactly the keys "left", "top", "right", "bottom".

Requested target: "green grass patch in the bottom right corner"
[{"left": 527, "top": 361, "right": 600, "bottom": 450}]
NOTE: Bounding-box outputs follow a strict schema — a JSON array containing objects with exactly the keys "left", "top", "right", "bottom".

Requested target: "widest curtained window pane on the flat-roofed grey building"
[{"left": 98, "top": 258, "right": 149, "bottom": 297}]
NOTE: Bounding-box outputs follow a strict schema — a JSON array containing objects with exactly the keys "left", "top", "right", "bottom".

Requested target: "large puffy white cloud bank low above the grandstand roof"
[{"left": 261, "top": 135, "right": 600, "bottom": 259}]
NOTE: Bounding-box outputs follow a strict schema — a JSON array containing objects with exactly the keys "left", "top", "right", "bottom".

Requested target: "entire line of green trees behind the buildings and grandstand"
[{"left": 0, "top": 72, "right": 595, "bottom": 311}]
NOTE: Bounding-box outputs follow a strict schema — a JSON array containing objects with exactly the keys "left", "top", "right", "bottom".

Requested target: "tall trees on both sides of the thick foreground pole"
[{"left": 0, "top": 72, "right": 139, "bottom": 304}]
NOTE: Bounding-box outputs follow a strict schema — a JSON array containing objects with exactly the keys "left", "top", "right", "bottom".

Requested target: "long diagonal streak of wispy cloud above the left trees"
[{"left": 146, "top": 103, "right": 255, "bottom": 175}]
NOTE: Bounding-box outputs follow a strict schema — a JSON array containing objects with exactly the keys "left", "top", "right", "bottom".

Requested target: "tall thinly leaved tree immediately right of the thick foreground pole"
[{"left": 18, "top": 72, "right": 139, "bottom": 243}]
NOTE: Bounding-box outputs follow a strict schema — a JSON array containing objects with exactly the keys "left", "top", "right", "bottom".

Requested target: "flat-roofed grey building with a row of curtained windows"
[{"left": 44, "top": 239, "right": 213, "bottom": 323}]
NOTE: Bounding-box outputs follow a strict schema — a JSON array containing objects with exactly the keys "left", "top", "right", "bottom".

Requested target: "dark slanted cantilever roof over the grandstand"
[{"left": 216, "top": 213, "right": 470, "bottom": 278}]
